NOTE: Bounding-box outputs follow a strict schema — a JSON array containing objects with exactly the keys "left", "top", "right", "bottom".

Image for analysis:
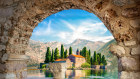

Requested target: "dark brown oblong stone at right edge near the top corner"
[{"left": 122, "top": 7, "right": 140, "bottom": 18}]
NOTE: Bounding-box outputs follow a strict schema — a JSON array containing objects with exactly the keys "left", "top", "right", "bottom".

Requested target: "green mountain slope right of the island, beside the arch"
[{"left": 97, "top": 40, "right": 118, "bottom": 69}]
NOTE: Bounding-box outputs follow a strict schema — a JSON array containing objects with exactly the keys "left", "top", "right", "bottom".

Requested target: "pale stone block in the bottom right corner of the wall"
[{"left": 120, "top": 71, "right": 140, "bottom": 79}]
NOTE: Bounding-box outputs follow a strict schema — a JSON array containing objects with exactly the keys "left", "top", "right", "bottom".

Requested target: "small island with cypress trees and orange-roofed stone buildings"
[{"left": 41, "top": 44, "right": 107, "bottom": 69}]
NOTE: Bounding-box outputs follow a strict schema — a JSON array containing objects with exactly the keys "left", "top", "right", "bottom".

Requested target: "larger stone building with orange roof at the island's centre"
[{"left": 68, "top": 54, "right": 86, "bottom": 67}]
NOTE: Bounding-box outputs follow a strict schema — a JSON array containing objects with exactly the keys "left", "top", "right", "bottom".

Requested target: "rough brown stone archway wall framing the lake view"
[{"left": 0, "top": 0, "right": 140, "bottom": 79}]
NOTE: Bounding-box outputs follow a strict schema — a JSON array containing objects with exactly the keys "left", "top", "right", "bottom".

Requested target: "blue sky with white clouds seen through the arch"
[{"left": 30, "top": 9, "right": 114, "bottom": 44}]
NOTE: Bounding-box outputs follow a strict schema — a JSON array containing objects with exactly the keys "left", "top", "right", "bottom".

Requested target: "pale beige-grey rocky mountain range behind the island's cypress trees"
[{"left": 26, "top": 39, "right": 105, "bottom": 64}]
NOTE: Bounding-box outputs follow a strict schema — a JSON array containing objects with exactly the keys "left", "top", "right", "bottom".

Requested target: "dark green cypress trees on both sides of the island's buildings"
[{"left": 44, "top": 45, "right": 107, "bottom": 65}]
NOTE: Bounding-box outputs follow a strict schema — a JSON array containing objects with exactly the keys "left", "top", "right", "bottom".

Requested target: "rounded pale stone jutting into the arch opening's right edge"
[{"left": 110, "top": 45, "right": 125, "bottom": 57}]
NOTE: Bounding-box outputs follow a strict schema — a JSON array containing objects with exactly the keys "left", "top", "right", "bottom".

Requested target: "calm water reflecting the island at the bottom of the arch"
[{"left": 27, "top": 69, "right": 118, "bottom": 79}]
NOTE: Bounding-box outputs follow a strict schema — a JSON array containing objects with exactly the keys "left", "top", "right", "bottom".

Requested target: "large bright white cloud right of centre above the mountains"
[{"left": 57, "top": 20, "right": 113, "bottom": 43}]
